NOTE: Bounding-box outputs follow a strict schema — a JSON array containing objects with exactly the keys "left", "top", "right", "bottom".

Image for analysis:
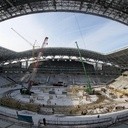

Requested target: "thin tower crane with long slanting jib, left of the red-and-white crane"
[{"left": 11, "top": 28, "right": 39, "bottom": 58}]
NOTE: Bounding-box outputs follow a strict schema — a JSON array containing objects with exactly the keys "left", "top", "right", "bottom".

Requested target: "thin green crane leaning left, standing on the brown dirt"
[{"left": 75, "top": 42, "right": 93, "bottom": 94}]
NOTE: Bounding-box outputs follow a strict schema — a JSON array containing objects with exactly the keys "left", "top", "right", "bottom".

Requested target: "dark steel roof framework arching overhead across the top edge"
[{"left": 0, "top": 0, "right": 128, "bottom": 25}]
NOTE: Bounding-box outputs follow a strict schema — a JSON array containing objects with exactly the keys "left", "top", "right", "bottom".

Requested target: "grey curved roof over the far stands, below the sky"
[{"left": 0, "top": 47, "right": 128, "bottom": 68}]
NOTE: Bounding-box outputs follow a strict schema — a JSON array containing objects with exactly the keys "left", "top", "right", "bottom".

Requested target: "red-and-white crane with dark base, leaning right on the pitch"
[{"left": 20, "top": 37, "right": 48, "bottom": 95}]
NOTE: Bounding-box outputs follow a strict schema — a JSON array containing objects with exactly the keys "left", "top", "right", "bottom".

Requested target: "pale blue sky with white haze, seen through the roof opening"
[{"left": 0, "top": 12, "right": 128, "bottom": 54}]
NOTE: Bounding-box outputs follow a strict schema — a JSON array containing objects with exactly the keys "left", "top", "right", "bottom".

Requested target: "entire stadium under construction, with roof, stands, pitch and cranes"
[{"left": 0, "top": 0, "right": 128, "bottom": 128}]
